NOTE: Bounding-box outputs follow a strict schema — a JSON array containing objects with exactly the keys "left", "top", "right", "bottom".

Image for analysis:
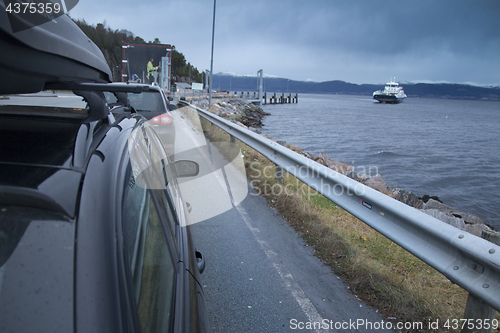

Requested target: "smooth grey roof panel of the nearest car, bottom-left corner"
[{"left": 0, "top": 206, "right": 74, "bottom": 332}]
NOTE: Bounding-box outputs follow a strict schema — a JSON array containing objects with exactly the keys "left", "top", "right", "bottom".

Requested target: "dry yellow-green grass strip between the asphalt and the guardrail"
[{"left": 178, "top": 102, "right": 499, "bottom": 332}]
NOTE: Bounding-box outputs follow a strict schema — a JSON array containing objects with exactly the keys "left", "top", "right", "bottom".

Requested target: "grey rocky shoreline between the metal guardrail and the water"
[{"left": 191, "top": 98, "right": 500, "bottom": 244}]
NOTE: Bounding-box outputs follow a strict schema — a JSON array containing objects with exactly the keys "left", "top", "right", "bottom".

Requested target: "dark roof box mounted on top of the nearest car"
[{"left": 0, "top": 6, "right": 112, "bottom": 94}]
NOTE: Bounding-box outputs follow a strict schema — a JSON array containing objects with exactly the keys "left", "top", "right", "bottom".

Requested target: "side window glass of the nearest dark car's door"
[{"left": 122, "top": 172, "right": 177, "bottom": 332}]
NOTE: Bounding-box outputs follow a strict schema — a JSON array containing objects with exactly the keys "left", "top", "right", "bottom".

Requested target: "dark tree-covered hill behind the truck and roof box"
[{"left": 73, "top": 19, "right": 201, "bottom": 82}]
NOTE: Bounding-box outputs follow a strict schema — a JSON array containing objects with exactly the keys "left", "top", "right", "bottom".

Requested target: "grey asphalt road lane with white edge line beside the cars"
[{"left": 174, "top": 105, "right": 394, "bottom": 332}]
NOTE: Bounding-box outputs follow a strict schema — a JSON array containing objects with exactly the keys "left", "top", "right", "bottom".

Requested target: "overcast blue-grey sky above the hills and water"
[{"left": 70, "top": 0, "right": 500, "bottom": 85}]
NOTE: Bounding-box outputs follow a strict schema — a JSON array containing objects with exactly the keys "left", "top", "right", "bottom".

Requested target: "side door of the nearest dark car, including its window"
[{"left": 119, "top": 125, "right": 208, "bottom": 332}]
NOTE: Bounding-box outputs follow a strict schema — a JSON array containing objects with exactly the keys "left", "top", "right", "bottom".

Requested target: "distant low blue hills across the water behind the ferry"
[{"left": 212, "top": 73, "right": 500, "bottom": 101}]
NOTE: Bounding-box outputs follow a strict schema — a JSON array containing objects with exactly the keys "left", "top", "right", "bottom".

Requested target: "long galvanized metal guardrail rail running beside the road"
[{"left": 183, "top": 102, "right": 500, "bottom": 311}]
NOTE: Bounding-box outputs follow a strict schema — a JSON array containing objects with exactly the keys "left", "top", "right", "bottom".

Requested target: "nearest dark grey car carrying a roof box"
[{"left": 0, "top": 9, "right": 208, "bottom": 332}]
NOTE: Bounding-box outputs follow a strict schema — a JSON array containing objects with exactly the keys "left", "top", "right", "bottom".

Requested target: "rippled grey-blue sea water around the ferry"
[{"left": 262, "top": 94, "right": 500, "bottom": 230}]
